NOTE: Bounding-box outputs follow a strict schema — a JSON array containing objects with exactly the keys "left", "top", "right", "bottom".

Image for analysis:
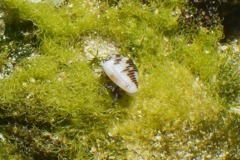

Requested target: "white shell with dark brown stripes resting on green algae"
[{"left": 102, "top": 54, "right": 138, "bottom": 96}]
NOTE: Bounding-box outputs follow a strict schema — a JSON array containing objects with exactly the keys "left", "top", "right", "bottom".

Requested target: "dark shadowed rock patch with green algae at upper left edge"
[{"left": 0, "top": 3, "right": 39, "bottom": 79}]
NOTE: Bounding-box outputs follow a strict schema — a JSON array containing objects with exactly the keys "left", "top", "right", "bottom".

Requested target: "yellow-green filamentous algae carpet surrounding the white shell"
[{"left": 0, "top": 0, "right": 240, "bottom": 160}]
